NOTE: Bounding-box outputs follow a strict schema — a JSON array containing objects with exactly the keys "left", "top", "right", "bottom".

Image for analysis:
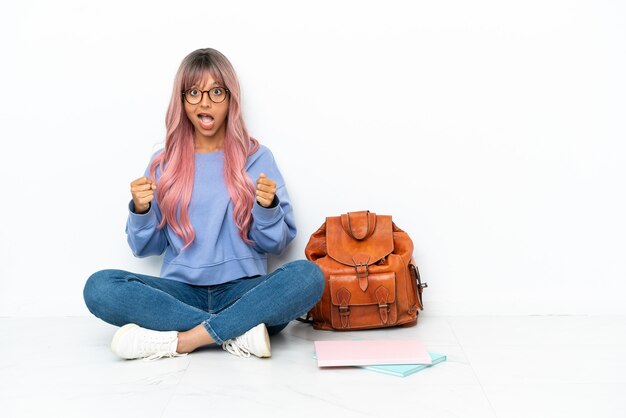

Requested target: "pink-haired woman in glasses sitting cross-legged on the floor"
[{"left": 84, "top": 49, "right": 324, "bottom": 359}]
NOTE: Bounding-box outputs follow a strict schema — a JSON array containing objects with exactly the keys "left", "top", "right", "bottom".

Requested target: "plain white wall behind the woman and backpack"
[{"left": 0, "top": 0, "right": 626, "bottom": 316}]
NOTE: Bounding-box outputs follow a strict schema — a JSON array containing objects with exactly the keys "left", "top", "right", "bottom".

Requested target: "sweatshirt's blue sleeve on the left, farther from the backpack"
[{"left": 126, "top": 153, "right": 168, "bottom": 257}]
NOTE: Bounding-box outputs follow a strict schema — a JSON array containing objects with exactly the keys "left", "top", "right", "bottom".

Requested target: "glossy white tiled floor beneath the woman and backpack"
[{"left": 0, "top": 314, "right": 626, "bottom": 418}]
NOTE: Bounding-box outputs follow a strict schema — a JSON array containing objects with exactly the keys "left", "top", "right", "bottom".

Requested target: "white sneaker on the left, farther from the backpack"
[{"left": 111, "top": 324, "right": 187, "bottom": 360}]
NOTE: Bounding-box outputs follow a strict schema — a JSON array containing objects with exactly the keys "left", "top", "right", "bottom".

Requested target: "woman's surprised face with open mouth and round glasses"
[{"left": 183, "top": 74, "right": 230, "bottom": 145}]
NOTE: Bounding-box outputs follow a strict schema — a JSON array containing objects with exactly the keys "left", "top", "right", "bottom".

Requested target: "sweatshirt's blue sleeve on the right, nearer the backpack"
[{"left": 248, "top": 146, "right": 297, "bottom": 255}]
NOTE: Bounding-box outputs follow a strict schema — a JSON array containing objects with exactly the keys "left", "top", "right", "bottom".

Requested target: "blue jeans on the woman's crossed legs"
[{"left": 83, "top": 260, "right": 324, "bottom": 344}]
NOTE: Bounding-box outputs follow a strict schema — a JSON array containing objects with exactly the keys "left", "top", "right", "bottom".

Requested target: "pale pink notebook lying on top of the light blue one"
[{"left": 314, "top": 340, "right": 432, "bottom": 367}]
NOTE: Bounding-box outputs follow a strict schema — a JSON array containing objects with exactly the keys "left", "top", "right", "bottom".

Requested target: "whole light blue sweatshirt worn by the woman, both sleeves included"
[{"left": 126, "top": 145, "right": 296, "bottom": 285}]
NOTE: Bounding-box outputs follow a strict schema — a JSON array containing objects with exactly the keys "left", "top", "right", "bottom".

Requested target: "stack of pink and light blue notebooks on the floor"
[{"left": 314, "top": 340, "right": 446, "bottom": 377}]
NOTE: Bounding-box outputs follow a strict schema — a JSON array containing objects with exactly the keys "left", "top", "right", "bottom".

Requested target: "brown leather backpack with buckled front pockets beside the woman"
[{"left": 305, "top": 211, "right": 428, "bottom": 331}]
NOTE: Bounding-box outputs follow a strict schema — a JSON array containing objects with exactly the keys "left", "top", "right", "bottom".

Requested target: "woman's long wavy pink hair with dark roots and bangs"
[{"left": 150, "top": 48, "right": 259, "bottom": 250}]
